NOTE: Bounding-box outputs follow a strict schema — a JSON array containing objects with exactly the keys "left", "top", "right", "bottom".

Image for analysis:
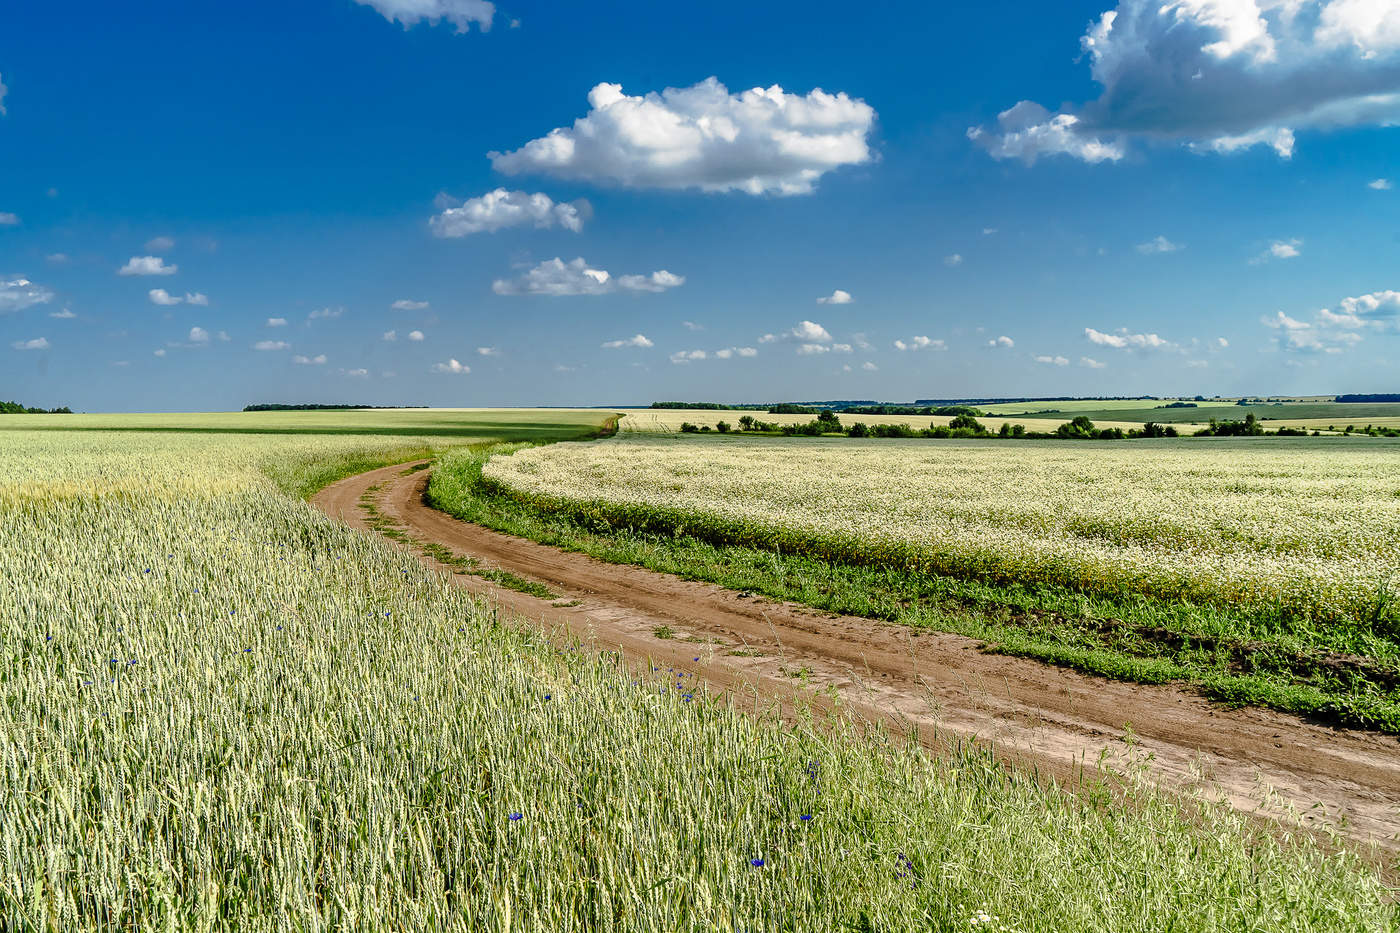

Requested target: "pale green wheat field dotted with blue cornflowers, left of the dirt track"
[{"left": 0, "top": 412, "right": 1397, "bottom": 932}]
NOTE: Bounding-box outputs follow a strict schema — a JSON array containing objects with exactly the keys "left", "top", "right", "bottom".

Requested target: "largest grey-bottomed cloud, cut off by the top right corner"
[{"left": 969, "top": 0, "right": 1400, "bottom": 163}]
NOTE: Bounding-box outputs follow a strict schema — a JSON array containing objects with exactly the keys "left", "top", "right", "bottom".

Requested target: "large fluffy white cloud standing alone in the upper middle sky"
[{"left": 490, "top": 77, "right": 875, "bottom": 195}]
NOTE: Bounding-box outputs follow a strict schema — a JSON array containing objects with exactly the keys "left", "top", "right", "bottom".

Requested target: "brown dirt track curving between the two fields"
[{"left": 312, "top": 467, "right": 1400, "bottom": 860}]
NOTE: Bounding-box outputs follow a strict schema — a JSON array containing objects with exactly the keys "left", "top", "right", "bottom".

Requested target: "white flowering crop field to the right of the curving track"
[{"left": 484, "top": 434, "right": 1400, "bottom": 619}]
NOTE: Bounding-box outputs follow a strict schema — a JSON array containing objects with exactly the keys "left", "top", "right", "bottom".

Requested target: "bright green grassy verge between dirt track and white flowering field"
[{"left": 428, "top": 445, "right": 1400, "bottom": 734}]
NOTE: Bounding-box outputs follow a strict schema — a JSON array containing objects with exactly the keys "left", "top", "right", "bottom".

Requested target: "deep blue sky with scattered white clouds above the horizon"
[{"left": 0, "top": 0, "right": 1400, "bottom": 410}]
